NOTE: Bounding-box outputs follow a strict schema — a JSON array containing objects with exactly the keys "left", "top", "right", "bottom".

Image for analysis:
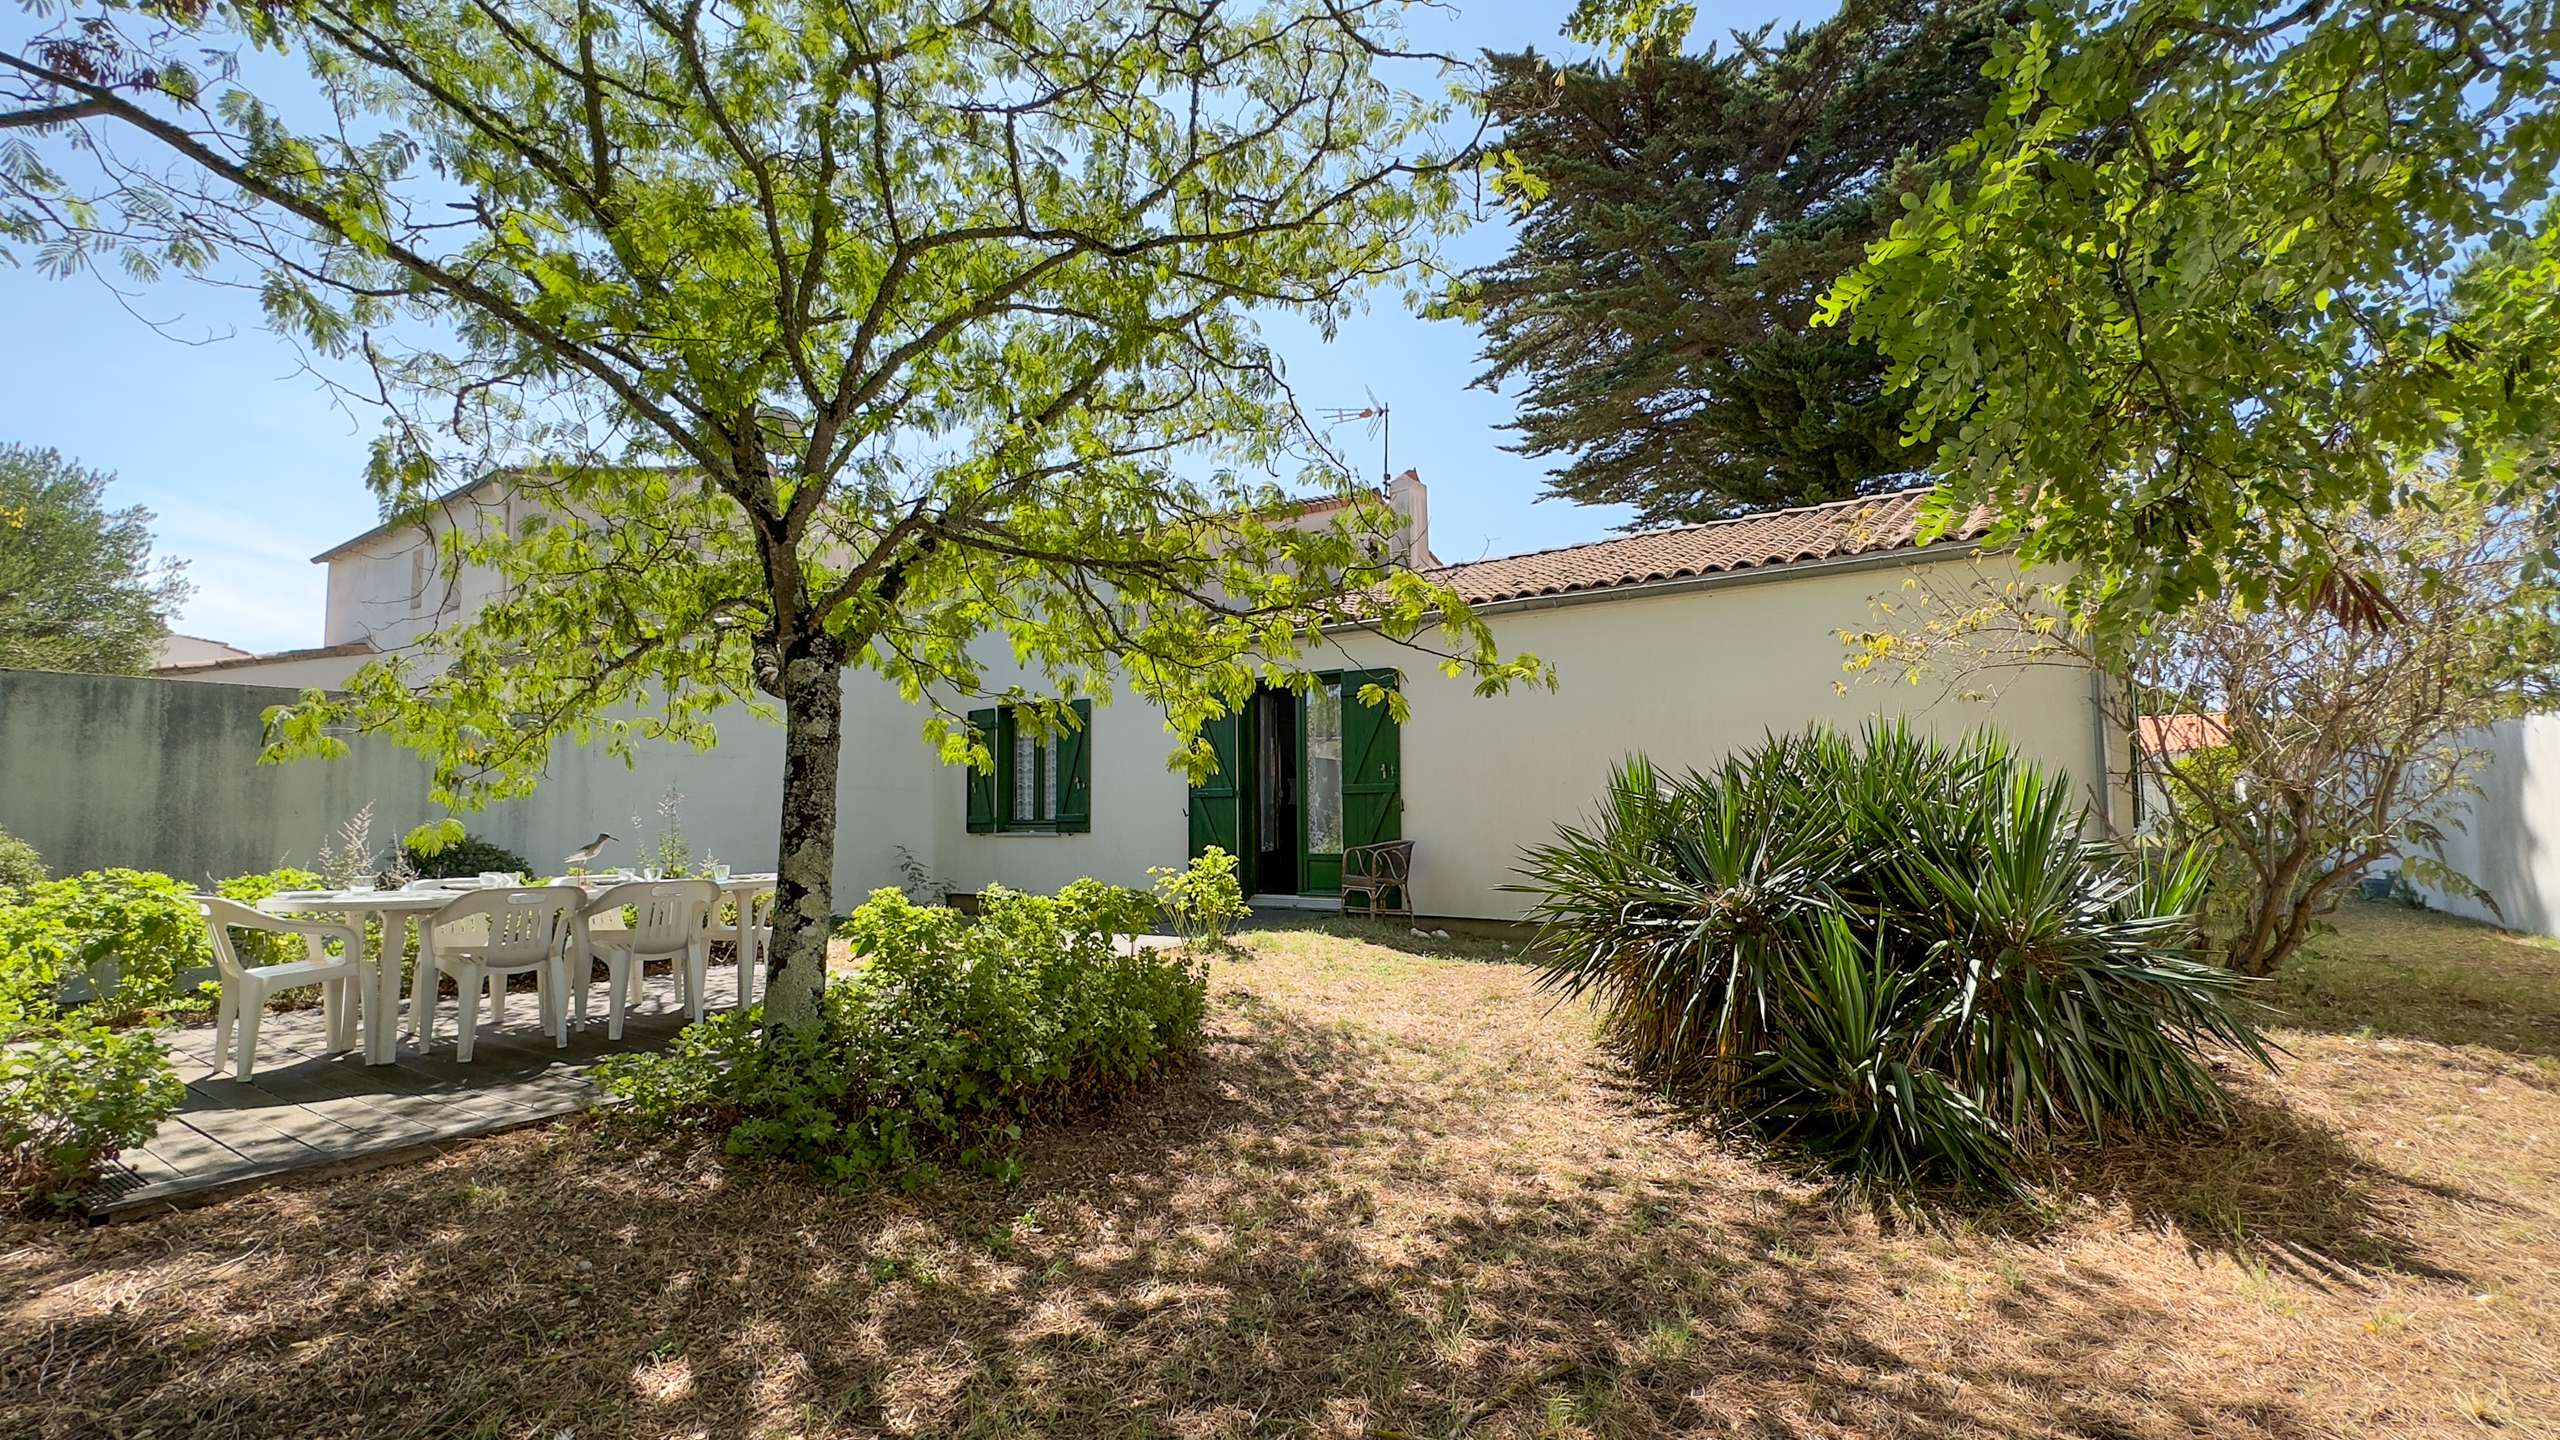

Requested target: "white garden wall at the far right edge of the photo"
[{"left": 2422, "top": 715, "right": 2560, "bottom": 935}]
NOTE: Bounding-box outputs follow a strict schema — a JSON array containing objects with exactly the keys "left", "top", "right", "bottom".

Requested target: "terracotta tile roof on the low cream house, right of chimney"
[{"left": 1428, "top": 487, "right": 1992, "bottom": 605}]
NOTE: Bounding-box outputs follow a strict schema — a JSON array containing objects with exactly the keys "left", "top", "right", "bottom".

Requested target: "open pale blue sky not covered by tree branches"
[{"left": 0, "top": 0, "right": 1836, "bottom": 651}]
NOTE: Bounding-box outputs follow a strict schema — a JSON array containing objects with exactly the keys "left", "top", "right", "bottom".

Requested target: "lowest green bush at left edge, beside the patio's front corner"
[{"left": 0, "top": 1027, "right": 187, "bottom": 1209}]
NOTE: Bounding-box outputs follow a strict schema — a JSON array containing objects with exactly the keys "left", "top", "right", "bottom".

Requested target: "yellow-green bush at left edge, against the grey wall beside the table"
[{"left": 0, "top": 869, "right": 212, "bottom": 1030}]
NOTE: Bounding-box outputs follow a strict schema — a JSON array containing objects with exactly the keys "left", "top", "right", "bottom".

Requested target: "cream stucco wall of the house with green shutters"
[{"left": 929, "top": 550, "right": 2130, "bottom": 920}]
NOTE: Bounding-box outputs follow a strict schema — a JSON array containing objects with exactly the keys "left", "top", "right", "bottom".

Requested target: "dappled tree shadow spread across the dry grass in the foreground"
[{"left": 0, "top": 997, "right": 2355, "bottom": 1437}]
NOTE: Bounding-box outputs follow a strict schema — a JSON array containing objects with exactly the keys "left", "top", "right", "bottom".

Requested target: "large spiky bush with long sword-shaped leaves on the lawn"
[{"left": 1516, "top": 725, "right": 2271, "bottom": 1186}]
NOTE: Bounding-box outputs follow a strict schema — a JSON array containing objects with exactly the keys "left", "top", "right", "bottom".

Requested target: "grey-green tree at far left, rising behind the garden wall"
[{"left": 0, "top": 443, "right": 189, "bottom": 674}]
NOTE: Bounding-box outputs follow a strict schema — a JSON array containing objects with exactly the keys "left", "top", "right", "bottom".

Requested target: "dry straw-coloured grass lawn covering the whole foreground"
[{"left": 0, "top": 907, "right": 2560, "bottom": 1440}]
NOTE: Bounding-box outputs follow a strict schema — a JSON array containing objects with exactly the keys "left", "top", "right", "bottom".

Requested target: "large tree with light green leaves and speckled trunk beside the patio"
[{"left": 10, "top": 0, "right": 1544, "bottom": 1022}]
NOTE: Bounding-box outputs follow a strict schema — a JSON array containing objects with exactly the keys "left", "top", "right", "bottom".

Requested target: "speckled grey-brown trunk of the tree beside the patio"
[{"left": 765, "top": 635, "right": 845, "bottom": 1025}]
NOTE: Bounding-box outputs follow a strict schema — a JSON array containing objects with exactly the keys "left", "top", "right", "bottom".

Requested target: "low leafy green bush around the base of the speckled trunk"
[{"left": 599, "top": 887, "right": 1206, "bottom": 1184}]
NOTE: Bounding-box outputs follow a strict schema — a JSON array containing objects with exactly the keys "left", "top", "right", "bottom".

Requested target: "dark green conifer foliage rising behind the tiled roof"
[{"left": 1454, "top": 0, "right": 2015, "bottom": 528}]
